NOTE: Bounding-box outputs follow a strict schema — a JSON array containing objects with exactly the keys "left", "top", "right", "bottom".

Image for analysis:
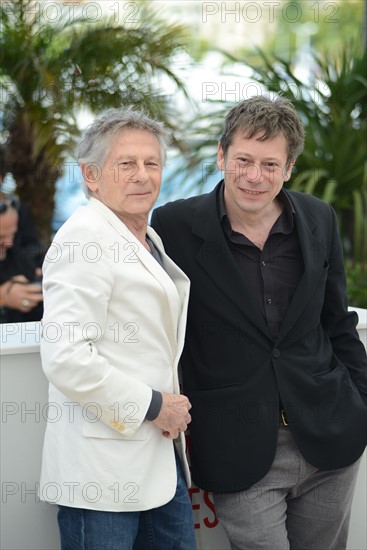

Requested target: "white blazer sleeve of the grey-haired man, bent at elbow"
[{"left": 41, "top": 218, "right": 152, "bottom": 436}]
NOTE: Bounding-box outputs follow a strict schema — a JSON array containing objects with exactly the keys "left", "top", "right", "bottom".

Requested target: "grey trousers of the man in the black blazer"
[{"left": 213, "top": 426, "right": 360, "bottom": 550}]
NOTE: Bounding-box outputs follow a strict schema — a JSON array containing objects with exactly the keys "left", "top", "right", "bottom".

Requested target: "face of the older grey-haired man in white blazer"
[{"left": 83, "top": 128, "right": 162, "bottom": 221}]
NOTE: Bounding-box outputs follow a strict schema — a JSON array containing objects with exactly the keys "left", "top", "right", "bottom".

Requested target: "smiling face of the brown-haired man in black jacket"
[{"left": 218, "top": 132, "right": 294, "bottom": 217}]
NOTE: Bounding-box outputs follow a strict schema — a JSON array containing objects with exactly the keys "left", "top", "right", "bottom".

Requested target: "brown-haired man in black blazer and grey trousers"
[{"left": 152, "top": 97, "right": 367, "bottom": 550}]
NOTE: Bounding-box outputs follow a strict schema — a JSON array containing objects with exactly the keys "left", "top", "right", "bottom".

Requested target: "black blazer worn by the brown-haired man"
[{"left": 152, "top": 184, "right": 367, "bottom": 492}]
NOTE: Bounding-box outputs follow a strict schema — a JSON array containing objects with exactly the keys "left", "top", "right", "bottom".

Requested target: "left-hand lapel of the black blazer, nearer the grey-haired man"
[{"left": 192, "top": 183, "right": 269, "bottom": 336}]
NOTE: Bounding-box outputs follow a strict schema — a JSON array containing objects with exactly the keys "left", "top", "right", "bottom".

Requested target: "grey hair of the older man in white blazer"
[{"left": 75, "top": 105, "right": 170, "bottom": 196}]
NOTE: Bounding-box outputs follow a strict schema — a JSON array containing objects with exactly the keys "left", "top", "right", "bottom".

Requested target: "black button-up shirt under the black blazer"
[{"left": 218, "top": 185, "right": 304, "bottom": 340}]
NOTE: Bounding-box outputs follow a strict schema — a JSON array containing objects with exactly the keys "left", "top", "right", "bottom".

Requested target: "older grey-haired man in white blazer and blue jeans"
[{"left": 40, "top": 108, "right": 195, "bottom": 550}]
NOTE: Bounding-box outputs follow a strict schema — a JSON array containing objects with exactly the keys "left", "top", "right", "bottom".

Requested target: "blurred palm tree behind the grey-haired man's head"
[{"left": 0, "top": 0, "right": 190, "bottom": 241}]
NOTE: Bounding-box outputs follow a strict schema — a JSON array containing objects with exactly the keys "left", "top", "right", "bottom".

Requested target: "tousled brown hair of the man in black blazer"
[{"left": 220, "top": 96, "right": 305, "bottom": 164}]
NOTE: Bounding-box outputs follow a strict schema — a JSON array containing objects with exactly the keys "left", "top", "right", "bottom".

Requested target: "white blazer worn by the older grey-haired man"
[{"left": 40, "top": 198, "right": 190, "bottom": 511}]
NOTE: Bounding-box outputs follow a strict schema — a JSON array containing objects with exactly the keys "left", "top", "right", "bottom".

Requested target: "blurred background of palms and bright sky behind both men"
[{"left": 0, "top": 0, "right": 367, "bottom": 308}]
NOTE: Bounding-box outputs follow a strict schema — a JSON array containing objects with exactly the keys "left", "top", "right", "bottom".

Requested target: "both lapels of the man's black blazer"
[{"left": 192, "top": 182, "right": 326, "bottom": 341}]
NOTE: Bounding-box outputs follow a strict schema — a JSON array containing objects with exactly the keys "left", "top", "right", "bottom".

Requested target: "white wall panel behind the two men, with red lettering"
[{"left": 0, "top": 308, "right": 367, "bottom": 550}]
